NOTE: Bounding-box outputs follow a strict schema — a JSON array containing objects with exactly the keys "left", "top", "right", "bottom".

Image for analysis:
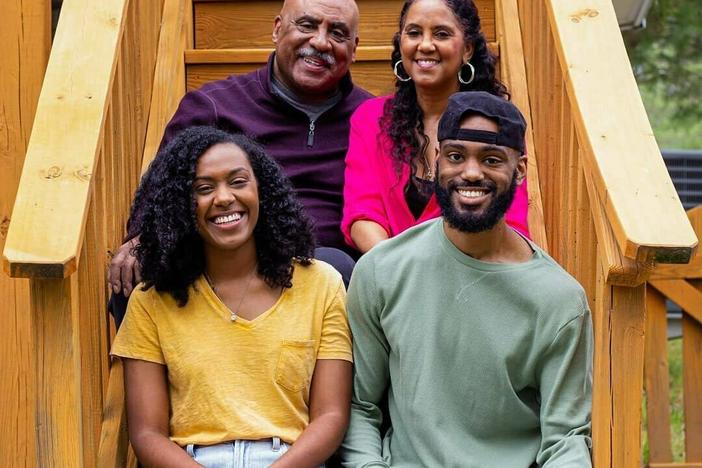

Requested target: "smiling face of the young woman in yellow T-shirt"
[{"left": 193, "top": 143, "right": 259, "bottom": 251}]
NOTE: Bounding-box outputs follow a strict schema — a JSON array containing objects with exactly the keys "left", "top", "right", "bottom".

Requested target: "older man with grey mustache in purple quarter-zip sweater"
[{"left": 109, "top": 0, "right": 371, "bottom": 316}]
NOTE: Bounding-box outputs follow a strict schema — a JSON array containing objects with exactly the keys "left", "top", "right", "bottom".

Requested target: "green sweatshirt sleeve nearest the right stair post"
[{"left": 536, "top": 310, "right": 593, "bottom": 468}]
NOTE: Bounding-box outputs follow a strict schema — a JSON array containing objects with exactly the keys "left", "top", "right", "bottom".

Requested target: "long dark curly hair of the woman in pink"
[{"left": 380, "top": 0, "right": 510, "bottom": 168}]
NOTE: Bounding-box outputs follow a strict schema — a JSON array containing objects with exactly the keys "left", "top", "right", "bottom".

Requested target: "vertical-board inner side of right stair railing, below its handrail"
[{"left": 516, "top": 0, "right": 598, "bottom": 300}]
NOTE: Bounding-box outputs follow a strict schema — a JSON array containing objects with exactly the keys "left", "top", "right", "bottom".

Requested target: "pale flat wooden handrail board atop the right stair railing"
[{"left": 546, "top": 0, "right": 697, "bottom": 263}]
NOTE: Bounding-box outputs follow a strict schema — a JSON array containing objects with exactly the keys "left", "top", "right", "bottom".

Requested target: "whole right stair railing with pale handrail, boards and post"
[{"left": 518, "top": 0, "right": 697, "bottom": 468}]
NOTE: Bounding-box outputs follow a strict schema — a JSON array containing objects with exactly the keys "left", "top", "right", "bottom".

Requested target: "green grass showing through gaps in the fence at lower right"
[{"left": 643, "top": 339, "right": 685, "bottom": 464}]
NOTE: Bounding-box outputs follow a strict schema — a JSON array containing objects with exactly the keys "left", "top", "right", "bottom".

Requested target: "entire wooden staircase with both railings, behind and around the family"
[{"left": 0, "top": 0, "right": 697, "bottom": 468}]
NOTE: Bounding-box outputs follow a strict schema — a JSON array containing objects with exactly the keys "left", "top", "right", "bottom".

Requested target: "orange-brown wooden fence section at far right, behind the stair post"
[{"left": 645, "top": 206, "right": 702, "bottom": 468}]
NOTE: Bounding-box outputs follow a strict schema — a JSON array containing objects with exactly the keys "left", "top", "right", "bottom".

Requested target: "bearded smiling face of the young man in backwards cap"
[{"left": 436, "top": 115, "right": 526, "bottom": 232}]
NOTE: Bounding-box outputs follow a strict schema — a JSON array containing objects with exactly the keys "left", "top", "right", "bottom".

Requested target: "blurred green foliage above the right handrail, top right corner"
[{"left": 624, "top": 0, "right": 702, "bottom": 148}]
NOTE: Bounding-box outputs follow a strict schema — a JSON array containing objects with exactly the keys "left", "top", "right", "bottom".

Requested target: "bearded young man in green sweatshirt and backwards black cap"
[{"left": 341, "top": 92, "right": 593, "bottom": 468}]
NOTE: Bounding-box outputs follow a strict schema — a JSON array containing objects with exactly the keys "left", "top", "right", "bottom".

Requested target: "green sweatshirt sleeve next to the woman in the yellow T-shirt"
[{"left": 341, "top": 256, "right": 390, "bottom": 468}]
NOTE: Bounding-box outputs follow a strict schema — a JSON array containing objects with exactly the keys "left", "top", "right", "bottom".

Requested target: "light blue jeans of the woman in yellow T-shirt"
[{"left": 185, "top": 437, "right": 324, "bottom": 468}]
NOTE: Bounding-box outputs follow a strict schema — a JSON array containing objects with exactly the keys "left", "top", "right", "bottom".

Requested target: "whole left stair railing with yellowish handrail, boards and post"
[{"left": 3, "top": 0, "right": 162, "bottom": 467}]
